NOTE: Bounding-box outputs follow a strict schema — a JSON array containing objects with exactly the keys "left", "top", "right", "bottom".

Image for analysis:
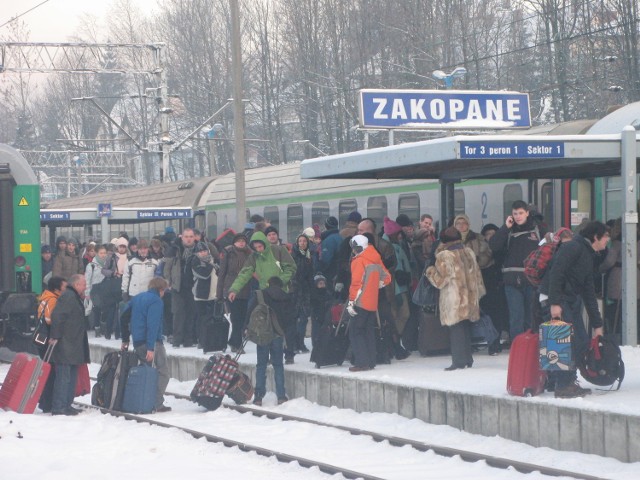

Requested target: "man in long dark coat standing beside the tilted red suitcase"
[{"left": 49, "top": 274, "right": 91, "bottom": 415}]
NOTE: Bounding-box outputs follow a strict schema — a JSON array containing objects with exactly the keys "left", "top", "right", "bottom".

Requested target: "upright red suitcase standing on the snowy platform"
[{"left": 507, "top": 330, "right": 547, "bottom": 397}]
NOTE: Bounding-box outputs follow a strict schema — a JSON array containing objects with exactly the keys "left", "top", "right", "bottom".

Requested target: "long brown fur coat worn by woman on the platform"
[{"left": 425, "top": 241, "right": 485, "bottom": 326}]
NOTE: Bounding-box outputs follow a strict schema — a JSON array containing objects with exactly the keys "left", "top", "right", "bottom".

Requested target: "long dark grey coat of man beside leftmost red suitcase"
[{"left": 51, "top": 286, "right": 91, "bottom": 365}]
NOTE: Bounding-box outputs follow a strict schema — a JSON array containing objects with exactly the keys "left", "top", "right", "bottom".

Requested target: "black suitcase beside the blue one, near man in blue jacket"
[{"left": 91, "top": 352, "right": 138, "bottom": 411}]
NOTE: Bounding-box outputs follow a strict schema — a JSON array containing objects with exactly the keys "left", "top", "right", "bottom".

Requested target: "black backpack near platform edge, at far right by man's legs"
[{"left": 578, "top": 336, "right": 624, "bottom": 390}]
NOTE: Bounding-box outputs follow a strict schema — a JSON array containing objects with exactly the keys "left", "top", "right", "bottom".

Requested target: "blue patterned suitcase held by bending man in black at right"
[{"left": 540, "top": 320, "right": 576, "bottom": 372}]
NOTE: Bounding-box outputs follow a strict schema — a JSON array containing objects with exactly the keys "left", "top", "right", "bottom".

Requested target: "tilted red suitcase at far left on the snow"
[{"left": 0, "top": 345, "right": 53, "bottom": 413}]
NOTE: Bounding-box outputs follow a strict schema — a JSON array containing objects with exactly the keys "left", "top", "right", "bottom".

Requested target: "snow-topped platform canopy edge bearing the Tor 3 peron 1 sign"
[{"left": 300, "top": 133, "right": 640, "bottom": 180}]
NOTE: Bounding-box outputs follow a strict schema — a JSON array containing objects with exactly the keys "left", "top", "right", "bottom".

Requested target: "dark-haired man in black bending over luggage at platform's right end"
[{"left": 548, "top": 221, "right": 609, "bottom": 398}]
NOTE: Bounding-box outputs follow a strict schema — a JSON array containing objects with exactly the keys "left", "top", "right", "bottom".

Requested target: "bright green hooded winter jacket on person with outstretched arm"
[{"left": 229, "top": 232, "right": 296, "bottom": 294}]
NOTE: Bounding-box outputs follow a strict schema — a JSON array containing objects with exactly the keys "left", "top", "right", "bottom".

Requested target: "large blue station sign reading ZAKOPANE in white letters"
[{"left": 360, "top": 90, "right": 531, "bottom": 130}]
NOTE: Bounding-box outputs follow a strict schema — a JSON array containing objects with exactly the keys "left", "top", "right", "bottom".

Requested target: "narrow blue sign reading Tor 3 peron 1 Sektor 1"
[{"left": 459, "top": 140, "right": 564, "bottom": 158}]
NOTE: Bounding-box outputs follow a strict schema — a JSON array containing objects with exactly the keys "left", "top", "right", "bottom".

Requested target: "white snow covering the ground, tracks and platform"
[{"left": 0, "top": 339, "right": 640, "bottom": 480}]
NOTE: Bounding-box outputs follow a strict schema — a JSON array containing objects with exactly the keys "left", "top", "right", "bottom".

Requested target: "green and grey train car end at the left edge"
[{"left": 0, "top": 144, "right": 42, "bottom": 346}]
